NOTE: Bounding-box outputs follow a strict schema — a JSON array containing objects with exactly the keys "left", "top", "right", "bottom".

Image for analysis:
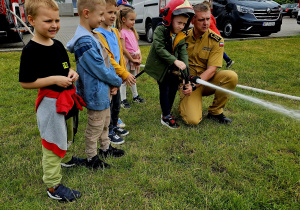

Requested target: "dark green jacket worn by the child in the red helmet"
[{"left": 145, "top": 25, "right": 189, "bottom": 82}]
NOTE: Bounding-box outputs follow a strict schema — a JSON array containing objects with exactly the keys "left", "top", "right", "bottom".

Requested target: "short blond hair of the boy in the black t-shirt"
[{"left": 25, "top": 0, "right": 59, "bottom": 18}]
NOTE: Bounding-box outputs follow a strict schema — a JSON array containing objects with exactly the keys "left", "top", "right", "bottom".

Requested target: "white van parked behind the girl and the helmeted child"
[{"left": 129, "top": 0, "right": 204, "bottom": 42}]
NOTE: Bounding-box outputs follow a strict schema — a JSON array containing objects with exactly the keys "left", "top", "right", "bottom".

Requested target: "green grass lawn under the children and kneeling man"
[{"left": 0, "top": 36, "right": 300, "bottom": 209}]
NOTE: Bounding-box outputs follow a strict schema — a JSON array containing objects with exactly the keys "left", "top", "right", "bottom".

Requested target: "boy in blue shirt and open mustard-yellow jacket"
[{"left": 94, "top": 0, "right": 135, "bottom": 144}]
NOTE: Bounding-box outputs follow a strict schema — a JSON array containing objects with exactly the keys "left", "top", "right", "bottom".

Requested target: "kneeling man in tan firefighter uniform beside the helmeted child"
[{"left": 178, "top": 3, "right": 238, "bottom": 125}]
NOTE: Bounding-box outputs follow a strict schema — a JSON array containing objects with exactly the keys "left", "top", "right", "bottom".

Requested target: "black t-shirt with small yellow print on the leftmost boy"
[{"left": 19, "top": 39, "right": 72, "bottom": 92}]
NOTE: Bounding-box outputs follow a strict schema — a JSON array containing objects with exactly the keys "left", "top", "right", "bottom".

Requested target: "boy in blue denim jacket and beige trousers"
[{"left": 67, "top": 0, "right": 124, "bottom": 169}]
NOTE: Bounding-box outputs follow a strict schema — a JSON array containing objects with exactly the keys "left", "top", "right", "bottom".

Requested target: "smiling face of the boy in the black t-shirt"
[{"left": 28, "top": 7, "right": 60, "bottom": 40}]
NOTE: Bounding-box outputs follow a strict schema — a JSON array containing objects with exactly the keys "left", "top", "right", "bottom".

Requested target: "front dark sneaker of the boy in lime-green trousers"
[{"left": 47, "top": 184, "right": 81, "bottom": 202}]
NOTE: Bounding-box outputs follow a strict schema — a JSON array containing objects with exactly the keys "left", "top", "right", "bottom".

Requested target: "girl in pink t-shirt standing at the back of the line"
[{"left": 116, "top": 7, "right": 145, "bottom": 109}]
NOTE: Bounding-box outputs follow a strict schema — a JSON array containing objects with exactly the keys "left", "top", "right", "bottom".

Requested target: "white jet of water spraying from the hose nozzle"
[{"left": 196, "top": 79, "right": 300, "bottom": 121}]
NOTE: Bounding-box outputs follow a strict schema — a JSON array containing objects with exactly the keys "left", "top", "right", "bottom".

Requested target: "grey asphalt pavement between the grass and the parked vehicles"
[{"left": 0, "top": 16, "right": 300, "bottom": 52}]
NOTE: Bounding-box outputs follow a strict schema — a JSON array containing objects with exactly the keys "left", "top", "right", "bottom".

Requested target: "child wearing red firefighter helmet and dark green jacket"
[{"left": 145, "top": 0, "right": 194, "bottom": 129}]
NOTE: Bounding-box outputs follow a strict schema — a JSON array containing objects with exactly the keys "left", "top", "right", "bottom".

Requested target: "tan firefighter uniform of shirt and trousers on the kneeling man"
[{"left": 178, "top": 29, "right": 238, "bottom": 125}]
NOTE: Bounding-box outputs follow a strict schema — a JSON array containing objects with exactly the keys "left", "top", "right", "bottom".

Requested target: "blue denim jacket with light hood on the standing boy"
[{"left": 67, "top": 25, "right": 122, "bottom": 110}]
